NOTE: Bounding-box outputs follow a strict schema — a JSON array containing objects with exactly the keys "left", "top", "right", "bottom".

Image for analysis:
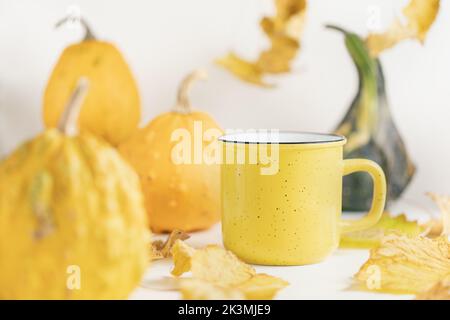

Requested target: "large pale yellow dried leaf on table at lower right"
[{"left": 355, "top": 235, "right": 450, "bottom": 294}]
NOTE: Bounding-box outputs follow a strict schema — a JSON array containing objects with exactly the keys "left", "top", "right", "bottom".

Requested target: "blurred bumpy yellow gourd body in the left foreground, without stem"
[{"left": 0, "top": 129, "right": 149, "bottom": 299}]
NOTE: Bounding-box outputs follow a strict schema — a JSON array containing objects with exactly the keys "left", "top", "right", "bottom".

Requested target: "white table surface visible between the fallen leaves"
[{"left": 130, "top": 202, "right": 436, "bottom": 300}]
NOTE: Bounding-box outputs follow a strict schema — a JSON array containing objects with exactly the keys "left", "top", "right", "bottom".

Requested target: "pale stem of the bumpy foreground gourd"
[{"left": 58, "top": 77, "right": 89, "bottom": 136}]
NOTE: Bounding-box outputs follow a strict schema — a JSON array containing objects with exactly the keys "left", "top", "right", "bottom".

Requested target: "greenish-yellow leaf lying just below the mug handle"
[{"left": 339, "top": 212, "right": 425, "bottom": 249}]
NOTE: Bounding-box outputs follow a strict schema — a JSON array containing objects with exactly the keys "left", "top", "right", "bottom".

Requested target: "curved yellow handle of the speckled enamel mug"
[{"left": 340, "top": 159, "right": 386, "bottom": 233}]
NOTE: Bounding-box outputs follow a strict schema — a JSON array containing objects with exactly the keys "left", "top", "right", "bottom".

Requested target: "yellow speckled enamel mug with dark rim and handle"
[{"left": 219, "top": 131, "right": 386, "bottom": 265}]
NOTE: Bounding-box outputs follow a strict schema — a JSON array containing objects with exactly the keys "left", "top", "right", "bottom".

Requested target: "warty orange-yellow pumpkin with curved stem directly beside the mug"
[{"left": 119, "top": 71, "right": 222, "bottom": 232}]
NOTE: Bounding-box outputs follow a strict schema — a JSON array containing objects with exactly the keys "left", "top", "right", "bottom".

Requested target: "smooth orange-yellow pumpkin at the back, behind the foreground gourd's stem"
[{"left": 43, "top": 18, "right": 141, "bottom": 146}]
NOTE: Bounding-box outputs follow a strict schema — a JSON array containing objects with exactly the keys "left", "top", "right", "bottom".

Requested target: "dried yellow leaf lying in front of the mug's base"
[{"left": 172, "top": 241, "right": 288, "bottom": 299}]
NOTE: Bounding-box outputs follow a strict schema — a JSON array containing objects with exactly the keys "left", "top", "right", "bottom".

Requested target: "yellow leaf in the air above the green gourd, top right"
[{"left": 366, "top": 0, "right": 440, "bottom": 57}]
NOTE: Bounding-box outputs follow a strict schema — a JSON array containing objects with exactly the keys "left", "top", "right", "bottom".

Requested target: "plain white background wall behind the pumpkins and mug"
[{"left": 0, "top": 0, "right": 450, "bottom": 208}]
